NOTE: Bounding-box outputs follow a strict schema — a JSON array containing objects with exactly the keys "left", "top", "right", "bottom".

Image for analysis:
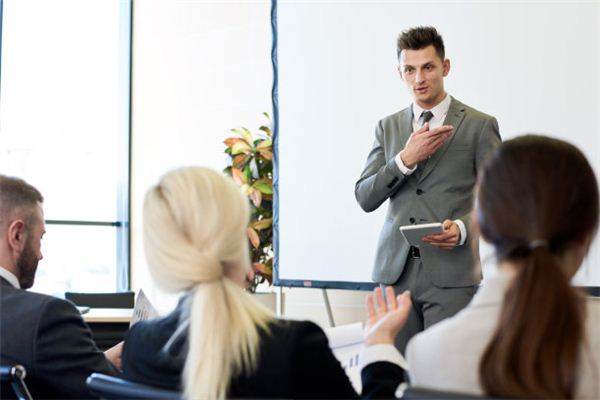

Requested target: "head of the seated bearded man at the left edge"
[{"left": 0, "top": 175, "right": 45, "bottom": 289}]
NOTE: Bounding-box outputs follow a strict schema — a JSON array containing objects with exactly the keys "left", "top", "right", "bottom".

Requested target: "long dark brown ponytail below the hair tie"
[{"left": 479, "top": 247, "right": 584, "bottom": 398}]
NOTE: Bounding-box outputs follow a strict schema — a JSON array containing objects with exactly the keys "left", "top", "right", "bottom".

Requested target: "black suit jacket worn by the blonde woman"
[{"left": 123, "top": 303, "right": 403, "bottom": 398}]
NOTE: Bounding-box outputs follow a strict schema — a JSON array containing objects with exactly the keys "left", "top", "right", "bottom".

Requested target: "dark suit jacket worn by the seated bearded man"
[{"left": 0, "top": 278, "right": 119, "bottom": 399}]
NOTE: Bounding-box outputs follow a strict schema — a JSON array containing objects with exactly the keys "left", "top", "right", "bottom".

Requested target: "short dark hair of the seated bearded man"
[{"left": 0, "top": 174, "right": 44, "bottom": 227}]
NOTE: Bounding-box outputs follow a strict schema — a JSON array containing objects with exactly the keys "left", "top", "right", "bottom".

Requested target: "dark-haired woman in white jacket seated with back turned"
[{"left": 407, "top": 135, "right": 600, "bottom": 399}]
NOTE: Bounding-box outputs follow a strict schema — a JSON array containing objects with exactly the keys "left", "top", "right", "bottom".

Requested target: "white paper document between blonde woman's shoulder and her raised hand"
[{"left": 325, "top": 322, "right": 364, "bottom": 393}]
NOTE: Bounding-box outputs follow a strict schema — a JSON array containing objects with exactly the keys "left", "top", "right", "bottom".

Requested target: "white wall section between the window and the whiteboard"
[{"left": 131, "top": 0, "right": 272, "bottom": 309}]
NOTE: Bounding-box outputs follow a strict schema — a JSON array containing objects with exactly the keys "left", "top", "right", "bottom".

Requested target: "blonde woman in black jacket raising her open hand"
[{"left": 123, "top": 167, "right": 411, "bottom": 399}]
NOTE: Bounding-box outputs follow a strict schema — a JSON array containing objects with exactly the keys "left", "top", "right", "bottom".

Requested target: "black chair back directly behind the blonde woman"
[{"left": 86, "top": 373, "right": 183, "bottom": 400}]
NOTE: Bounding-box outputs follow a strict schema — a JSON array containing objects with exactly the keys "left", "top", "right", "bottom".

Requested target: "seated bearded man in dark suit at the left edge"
[{"left": 0, "top": 175, "right": 121, "bottom": 399}]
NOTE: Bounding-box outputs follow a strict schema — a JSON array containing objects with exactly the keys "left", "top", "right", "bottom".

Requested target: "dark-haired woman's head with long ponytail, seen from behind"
[{"left": 475, "top": 135, "right": 599, "bottom": 398}]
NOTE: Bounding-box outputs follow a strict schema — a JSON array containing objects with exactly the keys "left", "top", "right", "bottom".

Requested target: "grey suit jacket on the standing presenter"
[{"left": 355, "top": 98, "right": 501, "bottom": 287}]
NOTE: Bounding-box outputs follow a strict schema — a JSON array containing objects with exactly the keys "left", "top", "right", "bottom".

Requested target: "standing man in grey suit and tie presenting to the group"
[{"left": 355, "top": 27, "right": 500, "bottom": 352}]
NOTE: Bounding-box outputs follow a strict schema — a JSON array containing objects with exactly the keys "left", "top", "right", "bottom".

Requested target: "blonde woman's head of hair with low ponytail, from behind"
[{"left": 144, "top": 167, "right": 272, "bottom": 398}]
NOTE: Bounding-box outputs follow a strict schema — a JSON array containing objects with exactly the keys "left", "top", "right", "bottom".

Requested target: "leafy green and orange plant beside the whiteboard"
[{"left": 223, "top": 113, "right": 273, "bottom": 292}]
